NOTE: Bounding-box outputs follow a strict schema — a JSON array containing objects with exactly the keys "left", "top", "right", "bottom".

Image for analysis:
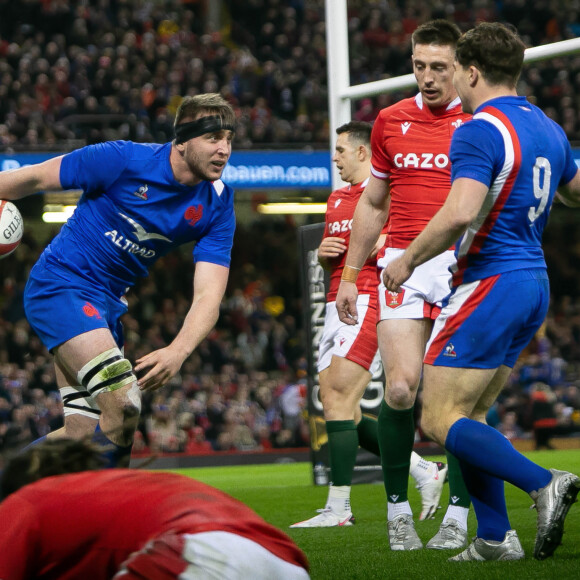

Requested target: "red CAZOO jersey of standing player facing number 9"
[{"left": 371, "top": 93, "right": 471, "bottom": 248}]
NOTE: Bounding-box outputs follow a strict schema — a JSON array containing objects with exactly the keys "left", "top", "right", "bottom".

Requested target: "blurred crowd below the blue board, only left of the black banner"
[{"left": 0, "top": 222, "right": 309, "bottom": 454}]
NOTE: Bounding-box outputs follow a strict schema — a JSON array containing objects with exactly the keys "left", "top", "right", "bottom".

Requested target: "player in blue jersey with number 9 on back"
[{"left": 374, "top": 23, "right": 580, "bottom": 561}]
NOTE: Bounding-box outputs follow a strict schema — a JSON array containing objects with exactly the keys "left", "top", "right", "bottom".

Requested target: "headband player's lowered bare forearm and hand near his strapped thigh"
[{"left": 135, "top": 262, "right": 229, "bottom": 391}]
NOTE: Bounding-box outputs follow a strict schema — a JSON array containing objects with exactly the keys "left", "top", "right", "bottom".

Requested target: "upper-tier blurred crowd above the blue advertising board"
[{"left": 0, "top": 0, "right": 580, "bottom": 150}]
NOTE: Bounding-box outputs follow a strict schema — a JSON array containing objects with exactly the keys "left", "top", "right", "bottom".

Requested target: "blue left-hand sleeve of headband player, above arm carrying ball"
[{"left": 60, "top": 141, "right": 133, "bottom": 192}]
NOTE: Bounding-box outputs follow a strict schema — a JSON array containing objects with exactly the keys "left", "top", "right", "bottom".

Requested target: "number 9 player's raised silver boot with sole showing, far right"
[{"left": 530, "top": 469, "right": 580, "bottom": 560}]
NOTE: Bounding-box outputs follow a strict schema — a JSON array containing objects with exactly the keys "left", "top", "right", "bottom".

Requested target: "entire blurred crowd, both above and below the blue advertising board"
[{"left": 0, "top": 0, "right": 580, "bottom": 460}]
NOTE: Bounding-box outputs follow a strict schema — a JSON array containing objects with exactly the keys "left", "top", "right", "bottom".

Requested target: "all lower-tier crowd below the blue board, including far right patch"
[{"left": 0, "top": 207, "right": 580, "bottom": 454}]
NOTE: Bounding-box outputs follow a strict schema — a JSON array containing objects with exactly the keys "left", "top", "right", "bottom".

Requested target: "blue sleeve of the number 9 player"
[{"left": 449, "top": 119, "right": 505, "bottom": 187}]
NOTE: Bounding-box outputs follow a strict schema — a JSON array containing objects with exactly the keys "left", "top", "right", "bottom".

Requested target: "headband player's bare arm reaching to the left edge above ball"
[{"left": 0, "top": 155, "right": 62, "bottom": 200}]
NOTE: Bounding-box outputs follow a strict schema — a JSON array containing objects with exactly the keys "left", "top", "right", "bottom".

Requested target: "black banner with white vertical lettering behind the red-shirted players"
[{"left": 298, "top": 223, "right": 384, "bottom": 485}]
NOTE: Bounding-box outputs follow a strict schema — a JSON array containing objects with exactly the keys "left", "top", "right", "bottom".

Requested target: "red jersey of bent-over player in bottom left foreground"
[{"left": 0, "top": 469, "right": 308, "bottom": 580}]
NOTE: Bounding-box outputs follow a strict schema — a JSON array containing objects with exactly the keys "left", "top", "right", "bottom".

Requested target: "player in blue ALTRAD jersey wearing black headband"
[{"left": 0, "top": 94, "right": 235, "bottom": 466}]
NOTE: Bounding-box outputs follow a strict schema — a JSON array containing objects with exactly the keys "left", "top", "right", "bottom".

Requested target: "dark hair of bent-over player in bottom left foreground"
[{"left": 0, "top": 438, "right": 105, "bottom": 498}]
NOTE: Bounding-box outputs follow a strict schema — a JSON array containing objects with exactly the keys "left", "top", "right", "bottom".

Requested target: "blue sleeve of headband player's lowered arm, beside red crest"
[{"left": 193, "top": 186, "right": 236, "bottom": 268}]
